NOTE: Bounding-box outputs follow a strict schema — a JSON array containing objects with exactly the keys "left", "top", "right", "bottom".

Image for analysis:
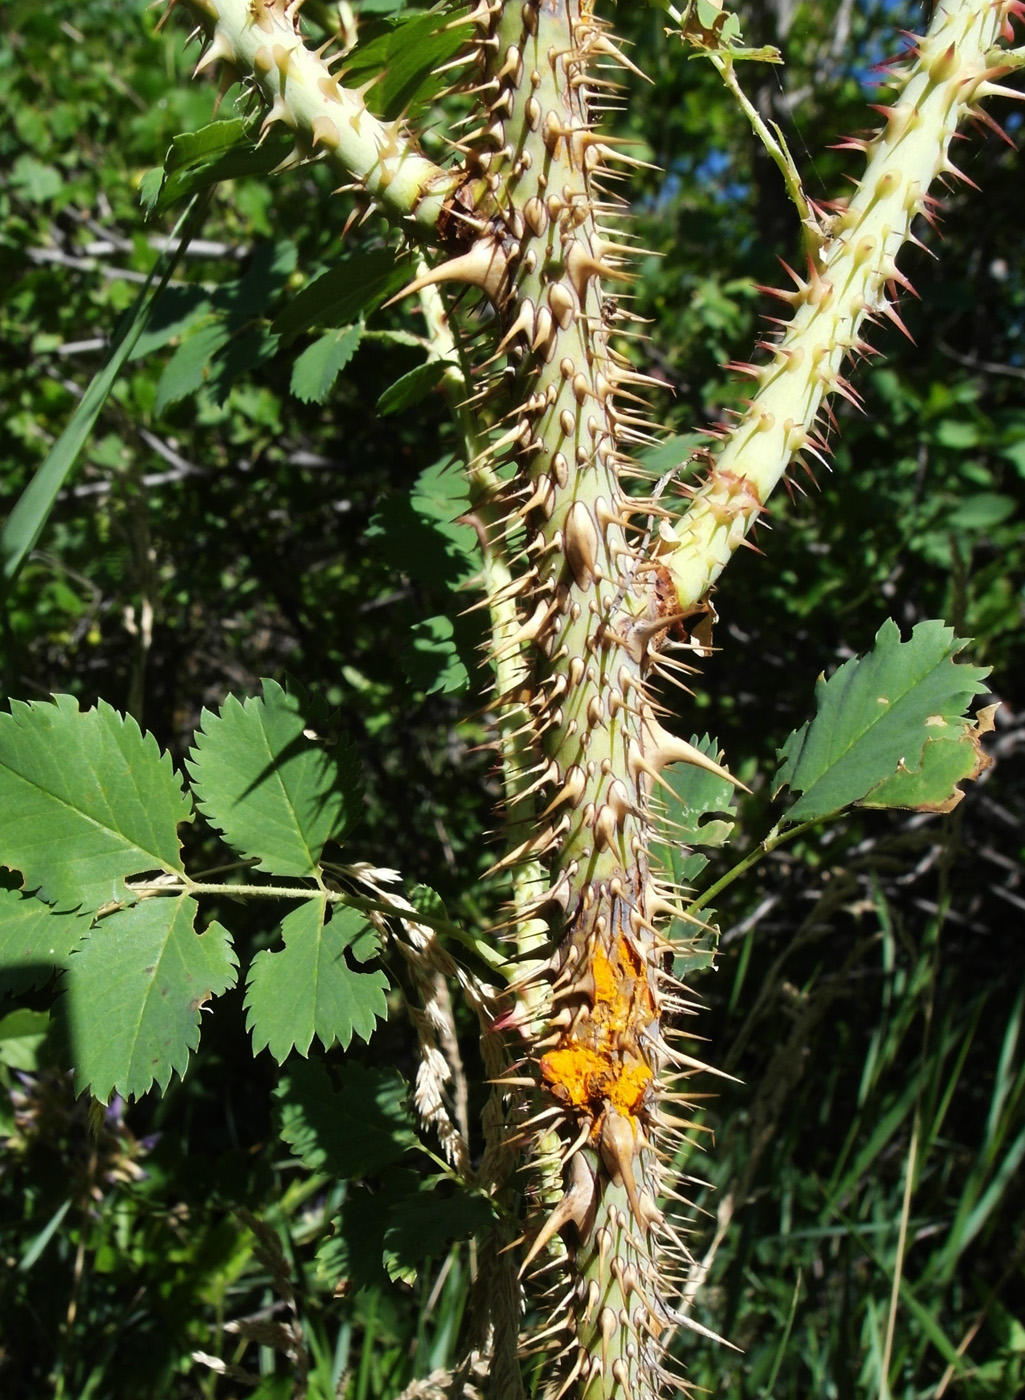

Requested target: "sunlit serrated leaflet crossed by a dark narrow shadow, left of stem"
[{"left": 188, "top": 680, "right": 361, "bottom": 876}]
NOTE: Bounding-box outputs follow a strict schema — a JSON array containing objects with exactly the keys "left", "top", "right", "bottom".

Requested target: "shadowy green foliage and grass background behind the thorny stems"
[{"left": 0, "top": 0, "right": 1025, "bottom": 1400}]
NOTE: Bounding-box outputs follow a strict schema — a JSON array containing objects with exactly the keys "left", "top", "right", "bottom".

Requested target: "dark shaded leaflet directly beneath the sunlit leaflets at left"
[{"left": 274, "top": 1061, "right": 417, "bottom": 1180}]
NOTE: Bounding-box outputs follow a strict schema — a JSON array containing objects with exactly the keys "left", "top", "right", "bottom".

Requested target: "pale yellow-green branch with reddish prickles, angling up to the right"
[{"left": 661, "top": 0, "right": 1025, "bottom": 608}]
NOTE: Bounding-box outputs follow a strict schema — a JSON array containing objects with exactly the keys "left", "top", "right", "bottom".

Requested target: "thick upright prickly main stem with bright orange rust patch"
[{"left": 414, "top": 0, "right": 739, "bottom": 1397}]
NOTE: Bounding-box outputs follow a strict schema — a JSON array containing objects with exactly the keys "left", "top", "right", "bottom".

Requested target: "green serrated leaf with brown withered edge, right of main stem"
[{"left": 776, "top": 620, "right": 989, "bottom": 823}]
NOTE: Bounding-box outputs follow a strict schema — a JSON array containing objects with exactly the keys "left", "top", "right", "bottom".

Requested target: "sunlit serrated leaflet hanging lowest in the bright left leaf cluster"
[{"left": 57, "top": 896, "right": 237, "bottom": 1103}]
